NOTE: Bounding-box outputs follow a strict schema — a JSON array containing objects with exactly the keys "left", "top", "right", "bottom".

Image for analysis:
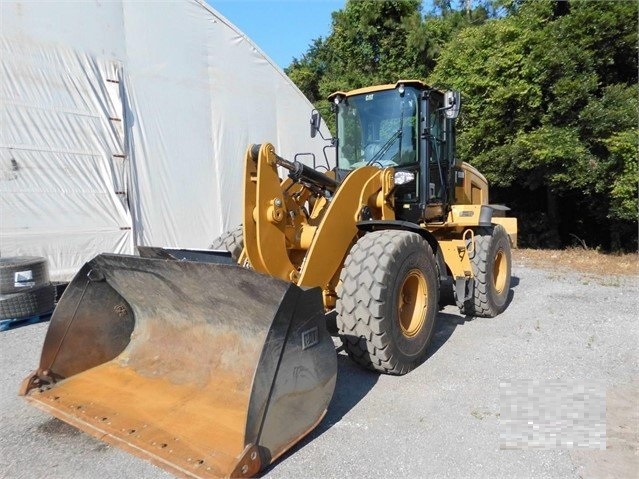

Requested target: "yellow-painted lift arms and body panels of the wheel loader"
[{"left": 239, "top": 143, "right": 517, "bottom": 310}]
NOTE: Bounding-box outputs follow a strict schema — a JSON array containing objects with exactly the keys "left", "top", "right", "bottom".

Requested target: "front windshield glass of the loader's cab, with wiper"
[{"left": 337, "top": 87, "right": 418, "bottom": 170}]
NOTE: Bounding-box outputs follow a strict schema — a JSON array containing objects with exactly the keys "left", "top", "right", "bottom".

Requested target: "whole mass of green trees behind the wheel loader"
[{"left": 286, "top": 0, "right": 639, "bottom": 250}]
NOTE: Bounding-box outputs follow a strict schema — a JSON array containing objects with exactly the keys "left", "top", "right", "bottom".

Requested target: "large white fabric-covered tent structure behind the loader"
[{"left": 0, "top": 0, "right": 328, "bottom": 280}]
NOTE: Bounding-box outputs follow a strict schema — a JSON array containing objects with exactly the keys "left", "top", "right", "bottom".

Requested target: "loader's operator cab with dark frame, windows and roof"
[{"left": 329, "top": 80, "right": 459, "bottom": 223}]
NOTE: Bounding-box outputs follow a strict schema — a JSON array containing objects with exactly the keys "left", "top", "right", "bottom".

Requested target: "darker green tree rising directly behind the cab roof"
[{"left": 286, "top": 0, "right": 489, "bottom": 131}]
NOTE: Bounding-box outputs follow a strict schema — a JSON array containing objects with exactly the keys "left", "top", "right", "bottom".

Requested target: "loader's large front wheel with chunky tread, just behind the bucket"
[{"left": 336, "top": 230, "right": 439, "bottom": 375}]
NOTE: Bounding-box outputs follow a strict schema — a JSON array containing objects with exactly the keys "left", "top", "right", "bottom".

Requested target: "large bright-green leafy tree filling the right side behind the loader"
[{"left": 429, "top": 1, "right": 637, "bottom": 251}]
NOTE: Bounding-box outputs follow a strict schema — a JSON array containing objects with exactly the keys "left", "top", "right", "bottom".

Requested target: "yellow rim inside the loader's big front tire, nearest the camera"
[{"left": 397, "top": 269, "right": 428, "bottom": 338}]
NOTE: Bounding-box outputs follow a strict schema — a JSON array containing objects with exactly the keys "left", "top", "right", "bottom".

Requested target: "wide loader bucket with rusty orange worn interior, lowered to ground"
[{"left": 21, "top": 255, "right": 337, "bottom": 478}]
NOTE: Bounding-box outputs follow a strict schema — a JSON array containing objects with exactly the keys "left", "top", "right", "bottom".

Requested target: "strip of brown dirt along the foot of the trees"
[{"left": 513, "top": 248, "right": 639, "bottom": 276}]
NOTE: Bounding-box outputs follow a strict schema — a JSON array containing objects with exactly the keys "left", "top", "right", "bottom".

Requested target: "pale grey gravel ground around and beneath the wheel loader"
[{"left": 0, "top": 262, "right": 639, "bottom": 479}]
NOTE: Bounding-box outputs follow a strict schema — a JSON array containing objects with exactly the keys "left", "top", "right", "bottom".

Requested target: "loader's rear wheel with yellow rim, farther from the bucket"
[{"left": 461, "top": 225, "right": 512, "bottom": 318}]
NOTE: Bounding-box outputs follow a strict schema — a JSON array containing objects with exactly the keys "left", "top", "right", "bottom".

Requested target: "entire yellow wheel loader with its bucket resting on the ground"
[{"left": 21, "top": 81, "right": 517, "bottom": 478}]
